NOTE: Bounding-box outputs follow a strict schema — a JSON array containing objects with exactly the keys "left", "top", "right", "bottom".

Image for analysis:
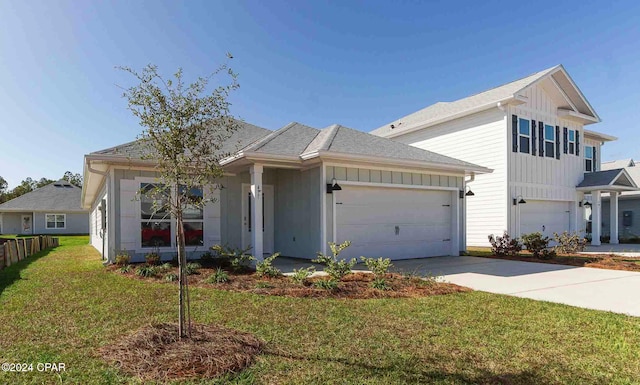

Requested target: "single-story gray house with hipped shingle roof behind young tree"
[{"left": 82, "top": 123, "right": 491, "bottom": 261}]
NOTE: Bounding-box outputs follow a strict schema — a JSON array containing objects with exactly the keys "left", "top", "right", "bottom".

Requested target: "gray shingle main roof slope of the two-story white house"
[{"left": 371, "top": 65, "right": 560, "bottom": 136}]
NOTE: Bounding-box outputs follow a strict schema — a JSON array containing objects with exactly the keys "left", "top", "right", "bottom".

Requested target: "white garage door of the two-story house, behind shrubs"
[{"left": 519, "top": 200, "right": 571, "bottom": 238}]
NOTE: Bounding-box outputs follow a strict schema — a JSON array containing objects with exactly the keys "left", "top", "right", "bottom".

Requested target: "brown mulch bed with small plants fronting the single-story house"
[{"left": 109, "top": 266, "right": 471, "bottom": 299}]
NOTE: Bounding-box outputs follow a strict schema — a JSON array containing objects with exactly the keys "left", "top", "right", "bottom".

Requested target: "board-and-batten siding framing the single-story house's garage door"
[{"left": 324, "top": 166, "right": 465, "bottom": 250}]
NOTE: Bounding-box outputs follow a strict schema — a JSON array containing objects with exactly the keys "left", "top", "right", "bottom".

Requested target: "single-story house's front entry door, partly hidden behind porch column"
[{"left": 242, "top": 184, "right": 274, "bottom": 254}]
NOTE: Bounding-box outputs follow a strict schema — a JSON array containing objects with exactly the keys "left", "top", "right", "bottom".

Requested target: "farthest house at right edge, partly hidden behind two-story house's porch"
[{"left": 602, "top": 159, "right": 640, "bottom": 241}]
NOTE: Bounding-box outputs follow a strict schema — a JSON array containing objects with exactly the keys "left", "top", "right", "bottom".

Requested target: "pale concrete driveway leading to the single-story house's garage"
[{"left": 393, "top": 257, "right": 640, "bottom": 317}]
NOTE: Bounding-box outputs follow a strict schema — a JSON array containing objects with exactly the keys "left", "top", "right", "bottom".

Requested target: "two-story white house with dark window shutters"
[{"left": 372, "top": 65, "right": 636, "bottom": 246}]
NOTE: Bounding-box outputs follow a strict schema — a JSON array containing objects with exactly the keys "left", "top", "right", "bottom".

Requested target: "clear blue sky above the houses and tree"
[{"left": 0, "top": 0, "right": 640, "bottom": 187}]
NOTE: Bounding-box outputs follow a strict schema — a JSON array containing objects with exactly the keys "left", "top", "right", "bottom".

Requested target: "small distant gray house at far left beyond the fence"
[{"left": 0, "top": 180, "right": 89, "bottom": 234}]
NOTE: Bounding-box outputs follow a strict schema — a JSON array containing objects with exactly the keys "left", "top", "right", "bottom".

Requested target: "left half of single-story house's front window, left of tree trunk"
[{"left": 140, "top": 183, "right": 173, "bottom": 247}]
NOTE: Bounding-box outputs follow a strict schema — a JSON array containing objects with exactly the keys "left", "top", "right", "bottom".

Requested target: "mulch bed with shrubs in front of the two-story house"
[{"left": 483, "top": 254, "right": 640, "bottom": 271}]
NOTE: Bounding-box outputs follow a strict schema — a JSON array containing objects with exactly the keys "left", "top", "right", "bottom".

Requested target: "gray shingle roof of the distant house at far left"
[{"left": 0, "top": 180, "right": 86, "bottom": 212}]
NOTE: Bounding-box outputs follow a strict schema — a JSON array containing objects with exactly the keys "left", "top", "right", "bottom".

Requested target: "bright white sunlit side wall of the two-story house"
[{"left": 394, "top": 108, "right": 508, "bottom": 246}]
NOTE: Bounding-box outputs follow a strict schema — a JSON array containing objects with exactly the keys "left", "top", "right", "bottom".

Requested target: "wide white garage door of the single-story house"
[{"left": 334, "top": 186, "right": 452, "bottom": 259}]
